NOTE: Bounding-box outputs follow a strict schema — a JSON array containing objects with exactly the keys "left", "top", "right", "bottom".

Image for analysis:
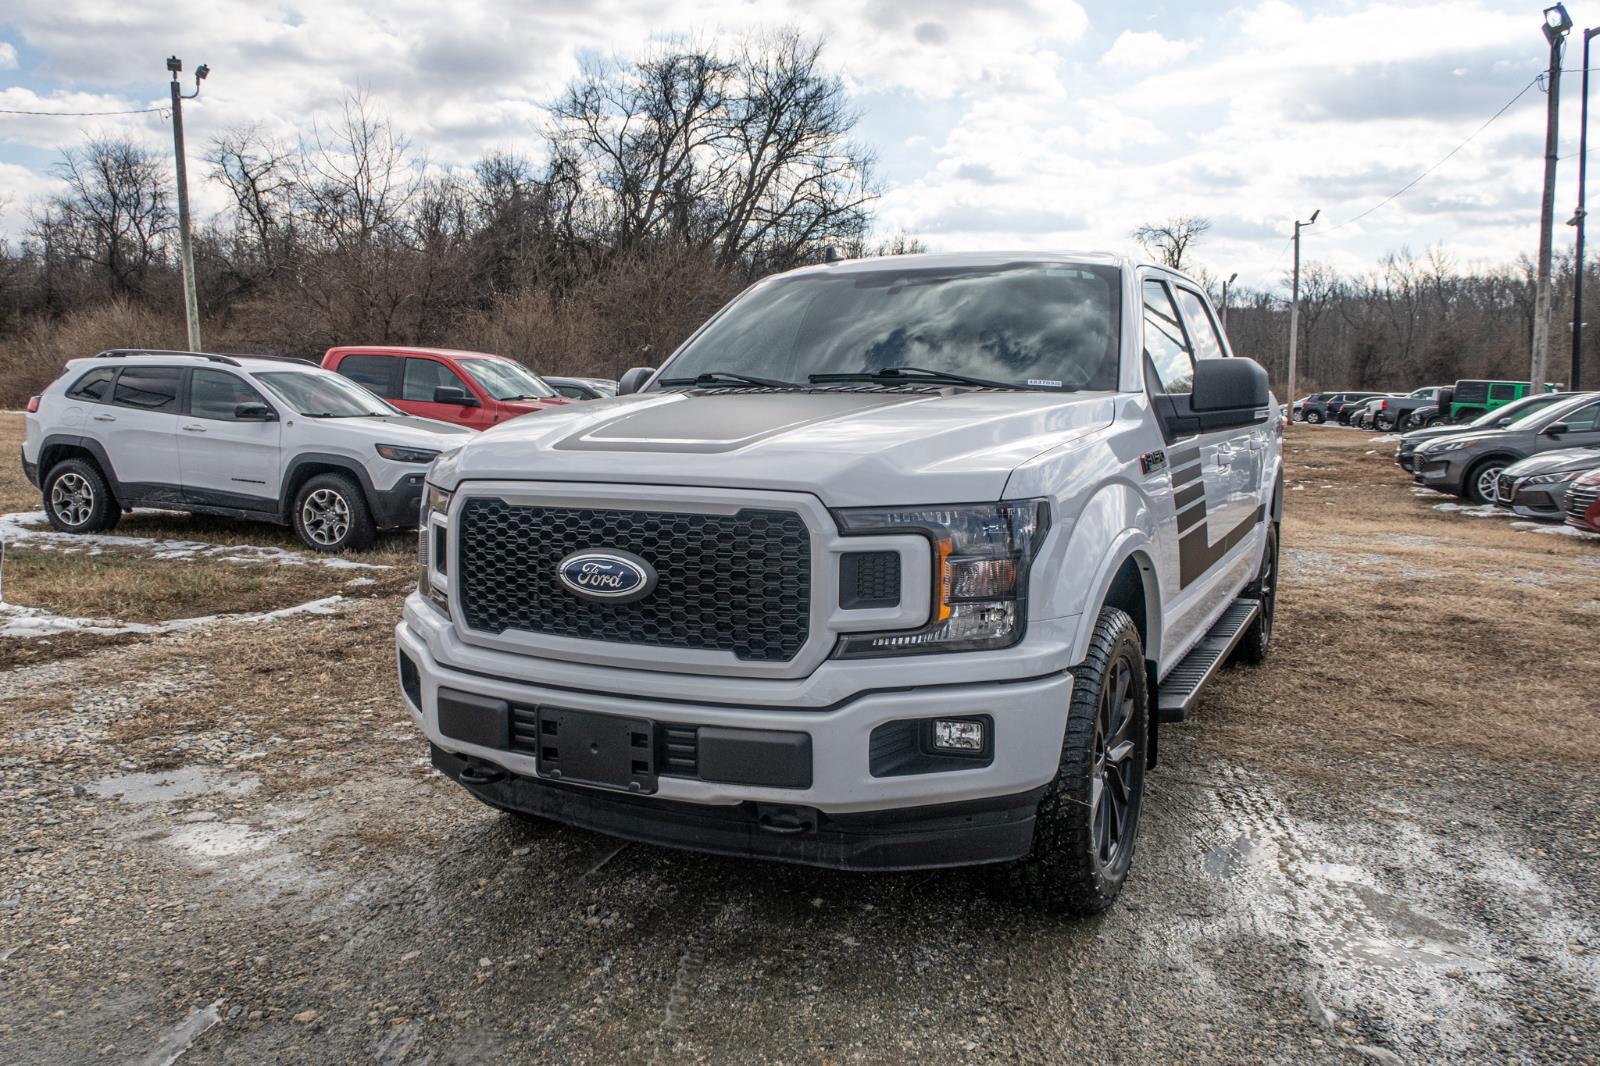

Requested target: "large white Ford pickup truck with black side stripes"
[{"left": 395, "top": 253, "right": 1283, "bottom": 912}]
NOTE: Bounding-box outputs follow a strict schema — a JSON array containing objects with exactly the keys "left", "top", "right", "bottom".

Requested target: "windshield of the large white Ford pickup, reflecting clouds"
[{"left": 659, "top": 264, "right": 1122, "bottom": 389}]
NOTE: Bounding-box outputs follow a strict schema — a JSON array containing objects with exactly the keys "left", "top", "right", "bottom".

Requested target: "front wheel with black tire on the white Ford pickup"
[{"left": 998, "top": 607, "right": 1150, "bottom": 914}]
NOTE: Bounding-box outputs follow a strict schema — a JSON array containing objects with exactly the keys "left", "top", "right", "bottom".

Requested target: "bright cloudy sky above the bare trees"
[{"left": 0, "top": 0, "right": 1600, "bottom": 285}]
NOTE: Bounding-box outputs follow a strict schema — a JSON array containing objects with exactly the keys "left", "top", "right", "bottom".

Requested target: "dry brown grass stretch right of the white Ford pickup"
[{"left": 1200, "top": 426, "right": 1600, "bottom": 762}]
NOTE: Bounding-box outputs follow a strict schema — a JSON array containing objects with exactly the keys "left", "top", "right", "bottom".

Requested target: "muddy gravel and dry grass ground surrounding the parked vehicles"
[{"left": 0, "top": 416, "right": 1600, "bottom": 1063}]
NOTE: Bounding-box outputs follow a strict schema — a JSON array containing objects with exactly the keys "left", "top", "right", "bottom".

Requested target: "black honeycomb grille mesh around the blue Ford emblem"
[{"left": 456, "top": 498, "right": 811, "bottom": 663}]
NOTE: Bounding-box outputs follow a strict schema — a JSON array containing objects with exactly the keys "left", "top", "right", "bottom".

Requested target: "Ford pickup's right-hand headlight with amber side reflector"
[{"left": 834, "top": 499, "right": 1050, "bottom": 658}]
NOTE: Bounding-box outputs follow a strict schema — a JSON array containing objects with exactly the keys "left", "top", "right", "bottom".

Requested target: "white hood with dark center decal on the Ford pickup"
[{"left": 430, "top": 389, "right": 1115, "bottom": 506}]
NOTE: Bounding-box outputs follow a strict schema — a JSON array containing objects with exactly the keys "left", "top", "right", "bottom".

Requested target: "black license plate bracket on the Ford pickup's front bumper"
[{"left": 536, "top": 707, "right": 656, "bottom": 794}]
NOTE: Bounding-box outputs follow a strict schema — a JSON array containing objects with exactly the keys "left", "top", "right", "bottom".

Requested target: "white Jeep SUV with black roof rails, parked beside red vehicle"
[{"left": 22, "top": 351, "right": 470, "bottom": 552}]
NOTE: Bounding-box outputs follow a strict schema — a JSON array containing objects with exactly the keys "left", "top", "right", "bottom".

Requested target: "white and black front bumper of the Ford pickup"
[{"left": 395, "top": 623, "right": 1072, "bottom": 869}]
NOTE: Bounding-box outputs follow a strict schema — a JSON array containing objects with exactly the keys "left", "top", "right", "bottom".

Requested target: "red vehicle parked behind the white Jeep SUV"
[{"left": 322, "top": 344, "right": 571, "bottom": 429}]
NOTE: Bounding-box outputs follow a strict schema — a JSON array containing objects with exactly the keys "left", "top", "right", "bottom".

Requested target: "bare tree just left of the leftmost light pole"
[{"left": 35, "top": 139, "right": 173, "bottom": 295}]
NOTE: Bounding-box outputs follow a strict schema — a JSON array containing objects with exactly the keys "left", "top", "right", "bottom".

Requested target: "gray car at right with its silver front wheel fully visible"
[{"left": 1416, "top": 392, "right": 1600, "bottom": 504}]
